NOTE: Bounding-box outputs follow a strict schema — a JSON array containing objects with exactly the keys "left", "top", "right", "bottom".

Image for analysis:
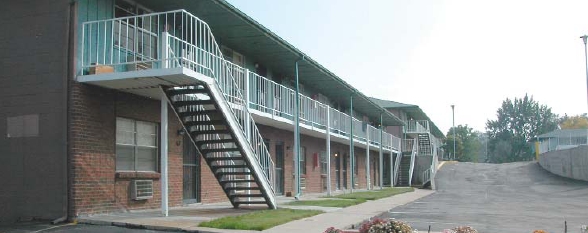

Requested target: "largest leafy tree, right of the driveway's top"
[{"left": 486, "top": 94, "right": 558, "bottom": 163}]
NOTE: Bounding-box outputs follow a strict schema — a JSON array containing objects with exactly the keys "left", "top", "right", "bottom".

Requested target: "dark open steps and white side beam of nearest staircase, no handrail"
[{"left": 163, "top": 83, "right": 276, "bottom": 208}]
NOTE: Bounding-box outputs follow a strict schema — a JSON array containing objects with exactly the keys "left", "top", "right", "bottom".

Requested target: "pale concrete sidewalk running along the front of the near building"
[{"left": 78, "top": 189, "right": 434, "bottom": 233}]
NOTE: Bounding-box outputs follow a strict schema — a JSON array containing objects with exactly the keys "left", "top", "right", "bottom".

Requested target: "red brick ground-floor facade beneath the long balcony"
[{"left": 70, "top": 82, "right": 396, "bottom": 217}]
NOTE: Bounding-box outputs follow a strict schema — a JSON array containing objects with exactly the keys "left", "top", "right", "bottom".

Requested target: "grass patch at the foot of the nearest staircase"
[{"left": 199, "top": 209, "right": 323, "bottom": 231}]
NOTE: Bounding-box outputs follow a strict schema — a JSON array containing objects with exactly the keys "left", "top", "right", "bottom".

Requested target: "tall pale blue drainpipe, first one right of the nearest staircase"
[{"left": 294, "top": 56, "right": 304, "bottom": 200}]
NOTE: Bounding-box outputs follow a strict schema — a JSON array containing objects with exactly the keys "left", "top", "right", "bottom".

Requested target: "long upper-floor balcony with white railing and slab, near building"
[{"left": 77, "top": 10, "right": 401, "bottom": 152}]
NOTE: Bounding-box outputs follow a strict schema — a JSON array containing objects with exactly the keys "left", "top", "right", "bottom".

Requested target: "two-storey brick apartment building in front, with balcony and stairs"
[{"left": 0, "top": 0, "right": 416, "bottom": 223}]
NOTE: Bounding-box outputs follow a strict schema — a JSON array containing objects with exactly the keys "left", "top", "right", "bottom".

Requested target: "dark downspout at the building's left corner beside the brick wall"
[{"left": 51, "top": 0, "right": 77, "bottom": 224}]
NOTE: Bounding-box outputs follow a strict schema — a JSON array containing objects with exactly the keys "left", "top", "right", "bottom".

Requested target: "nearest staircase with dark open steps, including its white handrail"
[{"left": 160, "top": 10, "right": 277, "bottom": 209}]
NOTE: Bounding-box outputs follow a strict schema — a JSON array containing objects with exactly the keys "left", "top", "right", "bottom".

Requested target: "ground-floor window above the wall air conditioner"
[{"left": 116, "top": 117, "right": 157, "bottom": 172}]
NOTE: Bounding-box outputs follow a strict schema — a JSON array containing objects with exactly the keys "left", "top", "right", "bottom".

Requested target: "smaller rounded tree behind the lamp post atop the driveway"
[{"left": 444, "top": 125, "right": 480, "bottom": 162}]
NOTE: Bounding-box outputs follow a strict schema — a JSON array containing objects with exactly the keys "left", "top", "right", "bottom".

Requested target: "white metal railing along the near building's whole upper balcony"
[{"left": 80, "top": 10, "right": 402, "bottom": 151}]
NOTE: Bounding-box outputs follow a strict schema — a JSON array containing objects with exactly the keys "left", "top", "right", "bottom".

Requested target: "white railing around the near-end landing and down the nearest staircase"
[{"left": 81, "top": 10, "right": 275, "bottom": 194}]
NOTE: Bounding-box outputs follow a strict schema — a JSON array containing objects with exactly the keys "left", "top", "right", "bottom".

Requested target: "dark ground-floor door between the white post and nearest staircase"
[{"left": 182, "top": 135, "right": 200, "bottom": 204}]
